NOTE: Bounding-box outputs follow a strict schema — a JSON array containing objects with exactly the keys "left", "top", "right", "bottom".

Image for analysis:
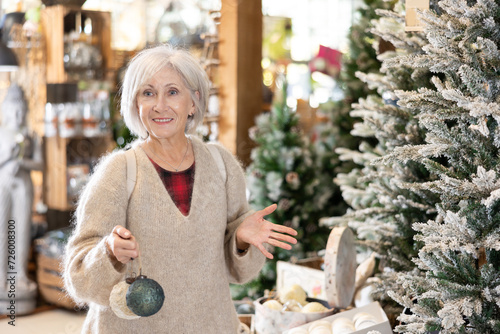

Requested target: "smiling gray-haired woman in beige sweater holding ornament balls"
[{"left": 64, "top": 45, "right": 296, "bottom": 334}]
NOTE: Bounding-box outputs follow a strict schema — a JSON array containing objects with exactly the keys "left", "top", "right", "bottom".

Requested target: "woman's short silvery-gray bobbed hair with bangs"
[{"left": 120, "top": 44, "right": 209, "bottom": 139}]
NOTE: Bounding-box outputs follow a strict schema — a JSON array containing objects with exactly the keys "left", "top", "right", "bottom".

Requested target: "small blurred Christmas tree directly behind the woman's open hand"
[{"left": 232, "top": 80, "right": 333, "bottom": 298}]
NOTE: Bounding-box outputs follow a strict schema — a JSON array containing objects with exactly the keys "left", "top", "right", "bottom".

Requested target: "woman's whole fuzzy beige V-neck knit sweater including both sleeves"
[{"left": 64, "top": 138, "right": 265, "bottom": 334}]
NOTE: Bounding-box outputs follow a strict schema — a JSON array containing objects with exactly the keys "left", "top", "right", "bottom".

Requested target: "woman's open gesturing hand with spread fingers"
[{"left": 236, "top": 204, "right": 297, "bottom": 259}]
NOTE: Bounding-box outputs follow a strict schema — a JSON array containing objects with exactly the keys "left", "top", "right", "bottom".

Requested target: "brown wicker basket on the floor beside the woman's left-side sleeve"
[{"left": 36, "top": 253, "right": 77, "bottom": 310}]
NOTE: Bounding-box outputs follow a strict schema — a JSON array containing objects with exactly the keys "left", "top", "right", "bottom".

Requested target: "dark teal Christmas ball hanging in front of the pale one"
[{"left": 126, "top": 275, "right": 165, "bottom": 317}]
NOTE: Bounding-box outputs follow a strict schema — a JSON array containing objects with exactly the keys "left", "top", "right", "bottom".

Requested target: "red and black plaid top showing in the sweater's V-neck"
[{"left": 149, "top": 158, "right": 194, "bottom": 216}]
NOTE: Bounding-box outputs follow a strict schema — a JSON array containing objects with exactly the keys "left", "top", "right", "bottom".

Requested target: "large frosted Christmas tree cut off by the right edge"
[{"left": 384, "top": 0, "right": 500, "bottom": 334}]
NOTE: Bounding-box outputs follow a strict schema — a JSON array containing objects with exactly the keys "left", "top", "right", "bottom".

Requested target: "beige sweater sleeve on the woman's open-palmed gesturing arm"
[{"left": 213, "top": 145, "right": 266, "bottom": 284}]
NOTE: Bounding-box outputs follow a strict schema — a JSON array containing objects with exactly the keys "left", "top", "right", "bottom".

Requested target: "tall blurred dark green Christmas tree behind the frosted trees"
[{"left": 311, "top": 0, "right": 394, "bottom": 222}]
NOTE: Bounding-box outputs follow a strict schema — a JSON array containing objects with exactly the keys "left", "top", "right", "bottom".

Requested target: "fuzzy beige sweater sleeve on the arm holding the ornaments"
[{"left": 63, "top": 153, "right": 128, "bottom": 306}]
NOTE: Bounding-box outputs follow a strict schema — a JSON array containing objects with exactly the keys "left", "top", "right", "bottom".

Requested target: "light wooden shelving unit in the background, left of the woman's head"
[{"left": 41, "top": 5, "right": 115, "bottom": 211}]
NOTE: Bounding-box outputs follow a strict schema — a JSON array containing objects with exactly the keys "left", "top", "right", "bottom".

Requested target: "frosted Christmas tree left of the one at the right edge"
[{"left": 322, "top": 3, "right": 438, "bottom": 315}]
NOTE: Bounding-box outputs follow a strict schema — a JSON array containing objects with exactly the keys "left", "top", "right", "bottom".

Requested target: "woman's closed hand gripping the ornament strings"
[{"left": 106, "top": 225, "right": 139, "bottom": 264}]
